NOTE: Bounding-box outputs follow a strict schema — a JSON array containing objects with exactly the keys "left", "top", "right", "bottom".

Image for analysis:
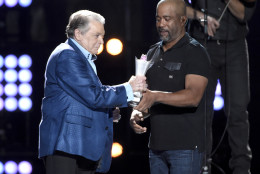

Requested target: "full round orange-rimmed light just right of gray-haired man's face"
[{"left": 106, "top": 38, "right": 123, "bottom": 56}]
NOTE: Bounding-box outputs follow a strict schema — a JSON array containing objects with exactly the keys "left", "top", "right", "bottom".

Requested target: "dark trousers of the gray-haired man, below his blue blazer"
[{"left": 44, "top": 152, "right": 98, "bottom": 174}]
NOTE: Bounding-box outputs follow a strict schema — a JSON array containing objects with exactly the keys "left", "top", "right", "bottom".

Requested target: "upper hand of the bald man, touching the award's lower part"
[{"left": 134, "top": 89, "right": 156, "bottom": 112}]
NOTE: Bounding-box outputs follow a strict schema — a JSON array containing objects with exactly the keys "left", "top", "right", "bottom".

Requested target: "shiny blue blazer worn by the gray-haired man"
[{"left": 39, "top": 39, "right": 127, "bottom": 172}]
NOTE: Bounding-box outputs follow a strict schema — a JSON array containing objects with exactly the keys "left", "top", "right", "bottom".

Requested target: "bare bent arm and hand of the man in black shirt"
[{"left": 135, "top": 74, "right": 208, "bottom": 111}]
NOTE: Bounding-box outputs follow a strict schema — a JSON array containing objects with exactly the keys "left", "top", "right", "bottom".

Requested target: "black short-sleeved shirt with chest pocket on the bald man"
[{"left": 146, "top": 33, "right": 209, "bottom": 151}]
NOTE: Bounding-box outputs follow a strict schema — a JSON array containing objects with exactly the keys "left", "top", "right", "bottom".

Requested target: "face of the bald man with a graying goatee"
[{"left": 156, "top": 2, "right": 183, "bottom": 43}]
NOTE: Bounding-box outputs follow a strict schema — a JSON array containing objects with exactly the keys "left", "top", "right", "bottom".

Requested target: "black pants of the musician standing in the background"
[{"left": 200, "top": 39, "right": 252, "bottom": 174}]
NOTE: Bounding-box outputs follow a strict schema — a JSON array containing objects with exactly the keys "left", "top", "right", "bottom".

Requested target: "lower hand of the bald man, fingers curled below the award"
[{"left": 130, "top": 110, "right": 147, "bottom": 134}]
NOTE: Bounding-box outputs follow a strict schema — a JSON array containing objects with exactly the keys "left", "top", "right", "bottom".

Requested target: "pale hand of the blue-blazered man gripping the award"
[{"left": 128, "top": 76, "right": 147, "bottom": 92}]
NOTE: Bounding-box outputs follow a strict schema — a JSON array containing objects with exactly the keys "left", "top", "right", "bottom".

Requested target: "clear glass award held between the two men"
[{"left": 129, "top": 54, "right": 150, "bottom": 107}]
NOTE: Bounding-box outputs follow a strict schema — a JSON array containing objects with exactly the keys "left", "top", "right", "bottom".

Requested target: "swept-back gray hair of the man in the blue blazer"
[{"left": 66, "top": 10, "right": 105, "bottom": 38}]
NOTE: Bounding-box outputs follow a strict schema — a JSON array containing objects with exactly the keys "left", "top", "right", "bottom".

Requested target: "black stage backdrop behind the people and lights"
[{"left": 0, "top": 0, "right": 260, "bottom": 174}]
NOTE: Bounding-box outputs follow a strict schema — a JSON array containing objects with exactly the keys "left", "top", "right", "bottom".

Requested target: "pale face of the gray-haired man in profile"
[{"left": 75, "top": 21, "right": 105, "bottom": 54}]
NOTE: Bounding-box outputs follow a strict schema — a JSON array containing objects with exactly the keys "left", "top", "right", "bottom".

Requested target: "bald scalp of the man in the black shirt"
[{"left": 157, "top": 0, "right": 186, "bottom": 16}]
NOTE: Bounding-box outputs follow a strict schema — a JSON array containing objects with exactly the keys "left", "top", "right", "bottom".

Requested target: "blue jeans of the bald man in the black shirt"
[{"left": 149, "top": 149, "right": 203, "bottom": 174}]
